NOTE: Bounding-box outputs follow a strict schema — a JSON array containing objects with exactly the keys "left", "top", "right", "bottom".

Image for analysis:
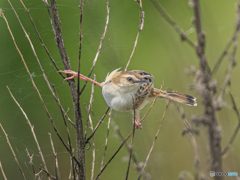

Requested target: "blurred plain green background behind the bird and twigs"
[{"left": 0, "top": 0, "right": 240, "bottom": 179}]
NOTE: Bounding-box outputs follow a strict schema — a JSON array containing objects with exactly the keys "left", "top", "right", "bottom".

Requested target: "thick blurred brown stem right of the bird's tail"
[{"left": 193, "top": 0, "right": 223, "bottom": 176}]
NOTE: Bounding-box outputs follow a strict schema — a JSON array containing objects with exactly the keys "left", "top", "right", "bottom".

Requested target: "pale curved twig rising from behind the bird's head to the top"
[{"left": 124, "top": 0, "right": 144, "bottom": 71}]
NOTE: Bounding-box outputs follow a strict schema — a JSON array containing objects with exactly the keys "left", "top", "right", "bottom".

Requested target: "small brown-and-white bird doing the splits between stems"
[{"left": 59, "top": 68, "right": 197, "bottom": 129}]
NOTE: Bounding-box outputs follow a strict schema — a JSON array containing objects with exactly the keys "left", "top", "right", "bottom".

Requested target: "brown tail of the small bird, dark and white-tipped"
[{"left": 149, "top": 88, "right": 197, "bottom": 106}]
